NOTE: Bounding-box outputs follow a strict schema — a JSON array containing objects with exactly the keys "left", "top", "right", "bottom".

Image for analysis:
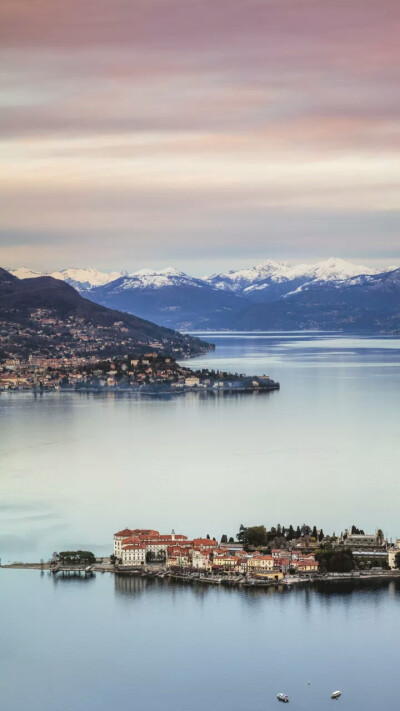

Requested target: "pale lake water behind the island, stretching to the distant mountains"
[{"left": 0, "top": 333, "right": 400, "bottom": 562}]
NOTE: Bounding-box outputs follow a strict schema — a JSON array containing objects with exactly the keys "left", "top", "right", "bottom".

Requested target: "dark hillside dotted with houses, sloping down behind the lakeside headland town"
[{"left": 0, "top": 268, "right": 208, "bottom": 356}]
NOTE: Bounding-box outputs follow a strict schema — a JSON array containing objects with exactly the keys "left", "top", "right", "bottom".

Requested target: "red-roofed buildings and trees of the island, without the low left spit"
[{"left": 111, "top": 524, "right": 400, "bottom": 583}]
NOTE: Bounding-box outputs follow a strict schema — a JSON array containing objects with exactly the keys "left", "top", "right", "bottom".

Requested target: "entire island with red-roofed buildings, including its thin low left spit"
[{"left": 3, "top": 524, "right": 400, "bottom": 587}]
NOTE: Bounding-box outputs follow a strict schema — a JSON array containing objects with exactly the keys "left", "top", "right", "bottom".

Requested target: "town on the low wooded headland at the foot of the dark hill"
[{"left": 0, "top": 351, "right": 279, "bottom": 395}]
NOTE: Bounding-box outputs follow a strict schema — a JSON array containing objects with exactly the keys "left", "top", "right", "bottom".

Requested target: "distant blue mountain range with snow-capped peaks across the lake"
[{"left": 9, "top": 259, "right": 400, "bottom": 331}]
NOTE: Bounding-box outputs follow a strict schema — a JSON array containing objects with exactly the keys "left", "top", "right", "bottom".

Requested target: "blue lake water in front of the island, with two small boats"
[{"left": 0, "top": 571, "right": 400, "bottom": 711}]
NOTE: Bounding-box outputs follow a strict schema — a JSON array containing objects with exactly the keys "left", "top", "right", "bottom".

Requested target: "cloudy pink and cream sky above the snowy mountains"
[{"left": 0, "top": 0, "right": 400, "bottom": 275}]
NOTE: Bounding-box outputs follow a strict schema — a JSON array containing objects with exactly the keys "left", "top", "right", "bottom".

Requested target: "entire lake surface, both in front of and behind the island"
[{"left": 0, "top": 334, "right": 400, "bottom": 711}]
